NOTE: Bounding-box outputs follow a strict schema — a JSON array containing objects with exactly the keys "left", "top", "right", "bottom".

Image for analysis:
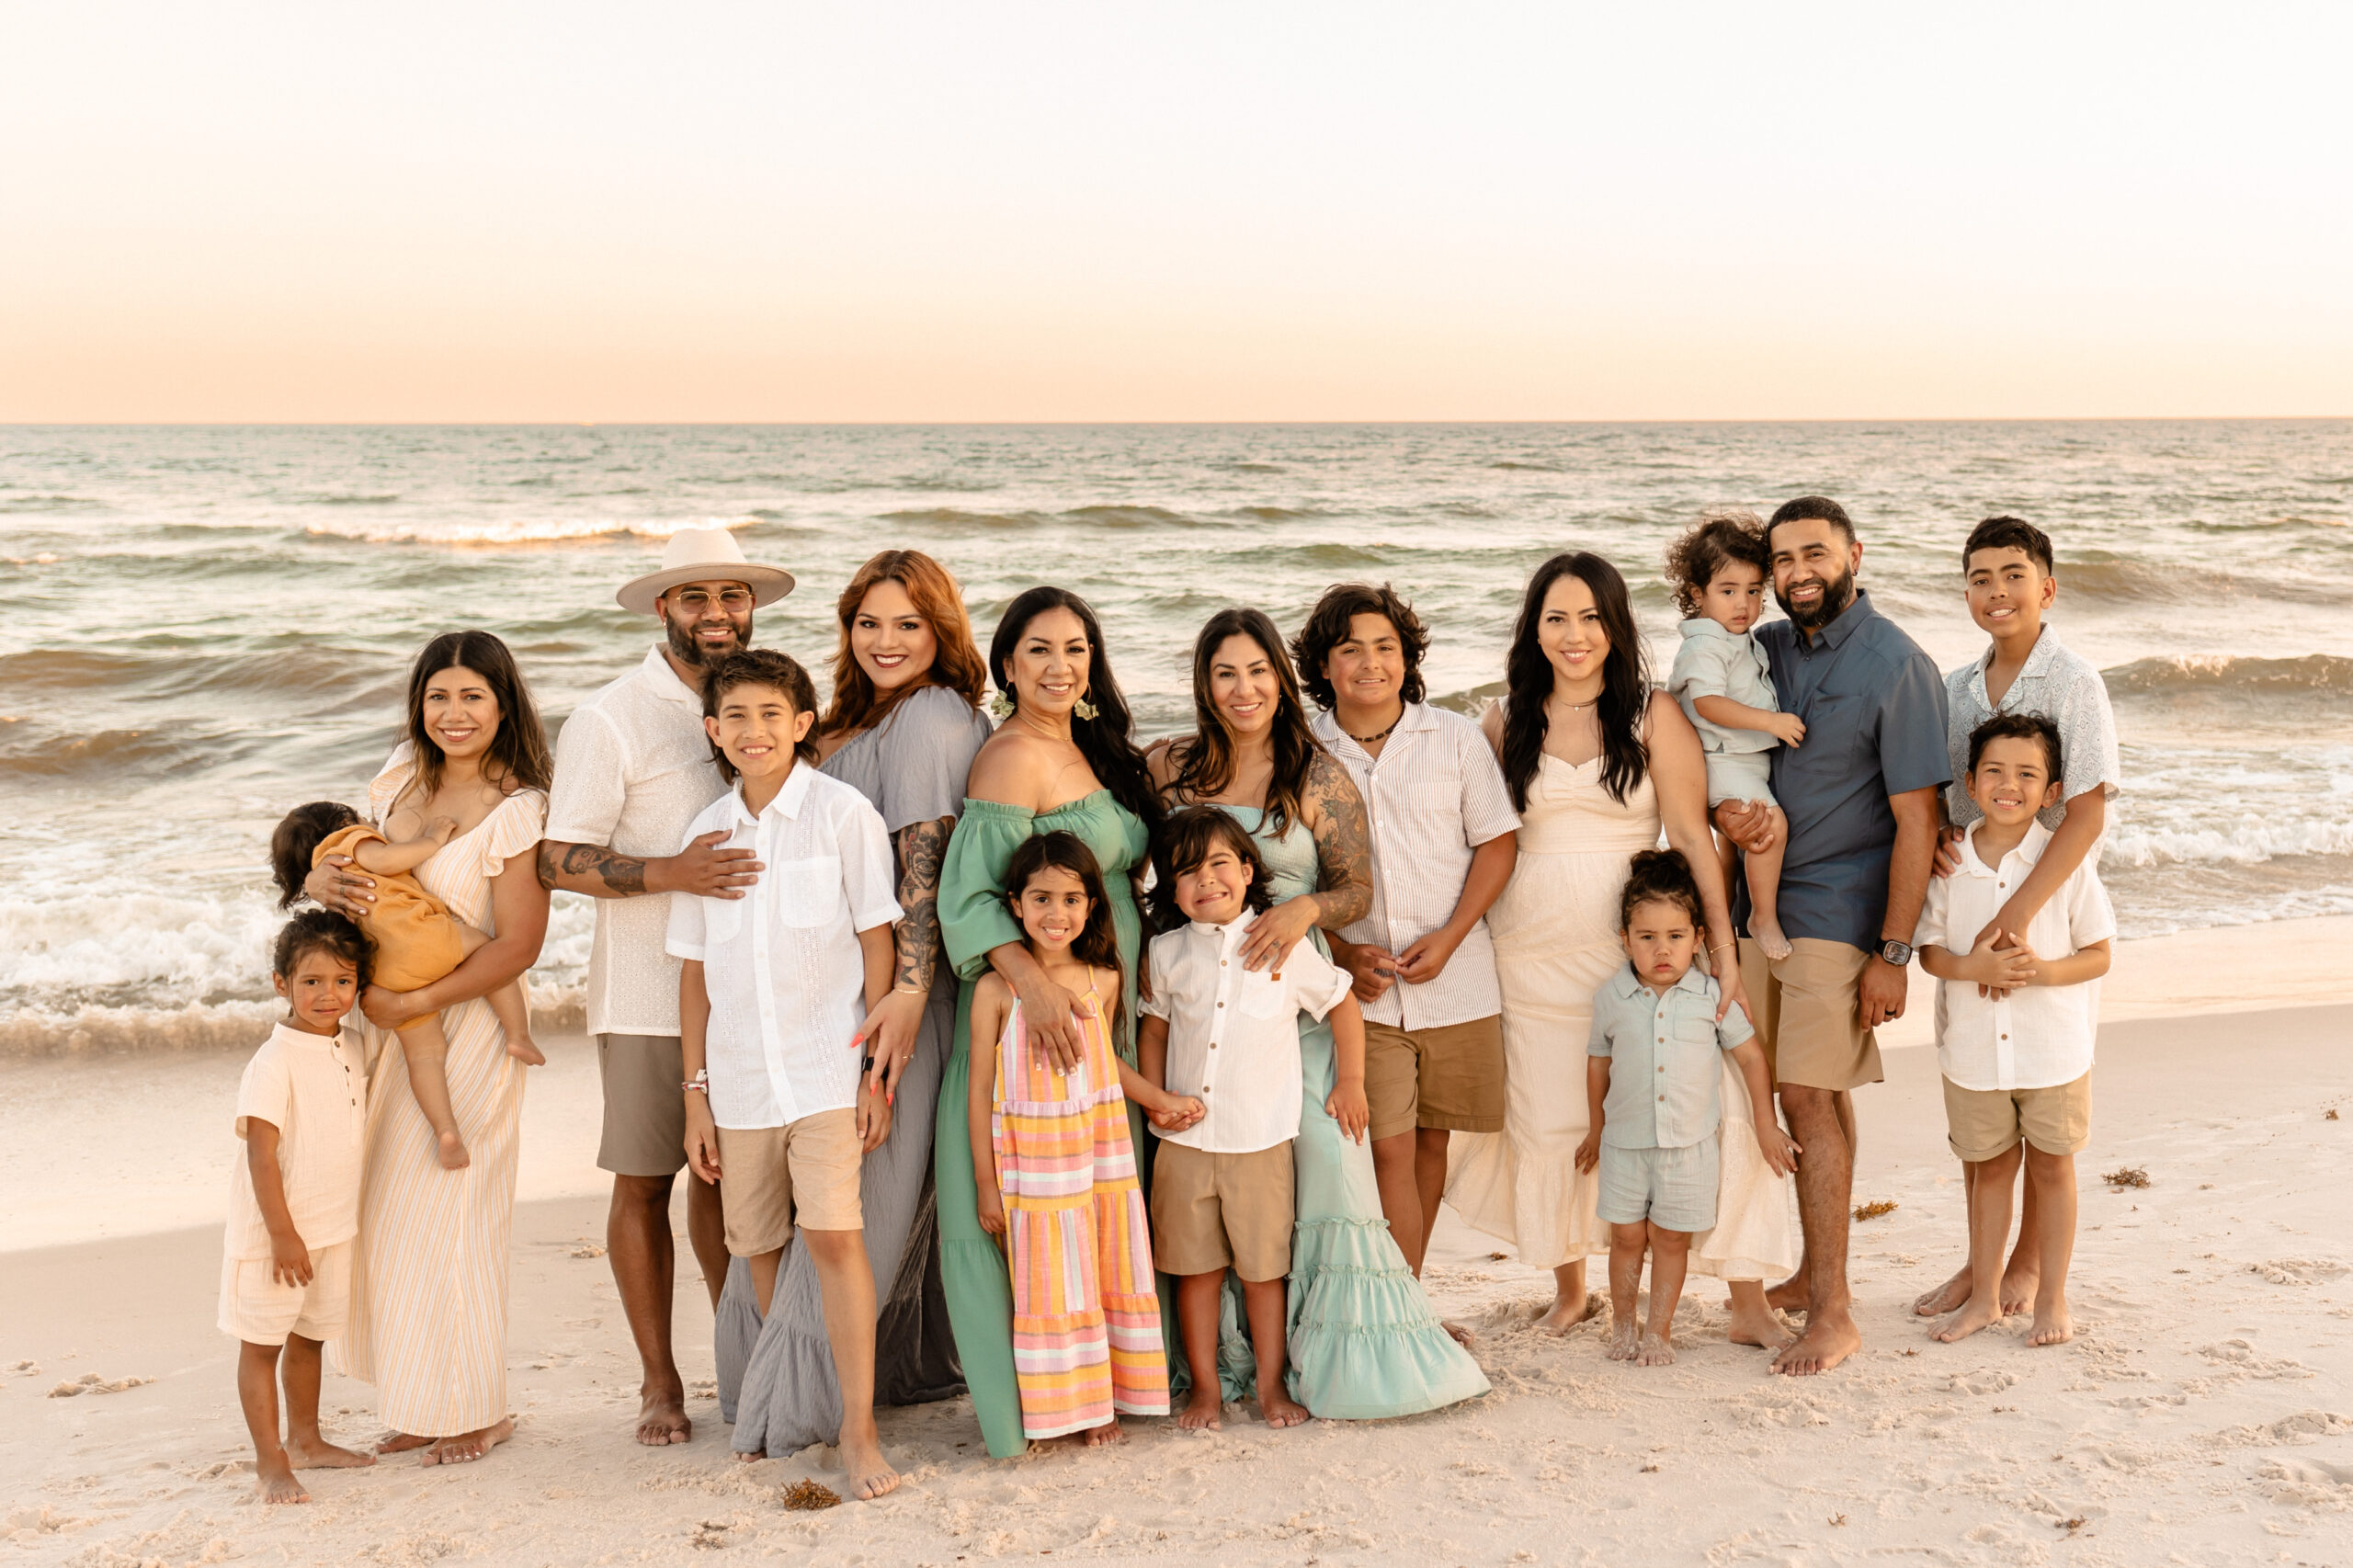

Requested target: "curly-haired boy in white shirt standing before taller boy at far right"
[{"left": 1917, "top": 713, "right": 2115, "bottom": 1345}]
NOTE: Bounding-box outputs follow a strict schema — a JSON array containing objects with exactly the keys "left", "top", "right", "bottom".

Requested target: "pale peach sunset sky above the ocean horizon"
[{"left": 0, "top": 0, "right": 2353, "bottom": 422}]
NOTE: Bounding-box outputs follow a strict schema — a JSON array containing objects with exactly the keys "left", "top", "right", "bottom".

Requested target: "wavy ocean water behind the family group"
[{"left": 0, "top": 422, "right": 2353, "bottom": 1050}]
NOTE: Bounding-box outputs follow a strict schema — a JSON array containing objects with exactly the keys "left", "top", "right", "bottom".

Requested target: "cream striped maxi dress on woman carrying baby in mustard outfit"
[{"left": 335, "top": 744, "right": 548, "bottom": 1438}]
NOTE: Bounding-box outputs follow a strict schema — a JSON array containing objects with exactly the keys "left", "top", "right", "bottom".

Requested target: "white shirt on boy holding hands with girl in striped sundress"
[{"left": 1139, "top": 921, "right": 1353, "bottom": 1153}]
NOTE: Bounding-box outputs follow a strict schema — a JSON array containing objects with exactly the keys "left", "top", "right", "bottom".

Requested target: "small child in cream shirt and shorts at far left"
[{"left": 222, "top": 909, "right": 377, "bottom": 1502}]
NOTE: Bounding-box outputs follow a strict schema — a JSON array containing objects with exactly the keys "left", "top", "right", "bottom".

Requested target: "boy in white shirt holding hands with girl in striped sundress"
[{"left": 1136, "top": 805, "right": 1370, "bottom": 1429}]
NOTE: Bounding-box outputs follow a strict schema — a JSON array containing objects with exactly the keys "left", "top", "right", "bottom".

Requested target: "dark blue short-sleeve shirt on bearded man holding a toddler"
[{"left": 1732, "top": 588, "right": 1953, "bottom": 953}]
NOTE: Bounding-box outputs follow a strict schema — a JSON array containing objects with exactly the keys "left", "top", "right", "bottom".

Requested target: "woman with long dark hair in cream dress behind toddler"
[{"left": 1447, "top": 551, "right": 1795, "bottom": 1346}]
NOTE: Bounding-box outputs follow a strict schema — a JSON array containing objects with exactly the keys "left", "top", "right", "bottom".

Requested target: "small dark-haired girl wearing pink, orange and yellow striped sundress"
[{"left": 970, "top": 834, "right": 1202, "bottom": 1446}]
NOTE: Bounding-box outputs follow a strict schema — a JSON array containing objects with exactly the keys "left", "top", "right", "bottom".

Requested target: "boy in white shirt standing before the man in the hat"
[{"left": 665, "top": 650, "right": 901, "bottom": 1500}]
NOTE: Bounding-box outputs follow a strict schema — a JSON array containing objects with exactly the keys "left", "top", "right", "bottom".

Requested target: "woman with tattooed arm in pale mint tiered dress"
[{"left": 1148, "top": 609, "right": 1487, "bottom": 1420}]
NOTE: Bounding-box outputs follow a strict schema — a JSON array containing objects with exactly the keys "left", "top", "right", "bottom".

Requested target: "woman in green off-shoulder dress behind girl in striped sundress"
[{"left": 932, "top": 588, "right": 1160, "bottom": 1458}]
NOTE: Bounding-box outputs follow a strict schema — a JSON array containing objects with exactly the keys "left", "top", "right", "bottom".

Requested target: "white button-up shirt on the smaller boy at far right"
[{"left": 1913, "top": 822, "right": 2115, "bottom": 1090}]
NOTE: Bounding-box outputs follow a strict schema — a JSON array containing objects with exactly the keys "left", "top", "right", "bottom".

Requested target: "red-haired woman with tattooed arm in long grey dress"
[{"left": 718, "top": 551, "right": 991, "bottom": 1458}]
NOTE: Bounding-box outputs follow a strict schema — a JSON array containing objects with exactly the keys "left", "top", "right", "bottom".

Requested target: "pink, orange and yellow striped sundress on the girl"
[{"left": 988, "top": 986, "right": 1169, "bottom": 1438}]
